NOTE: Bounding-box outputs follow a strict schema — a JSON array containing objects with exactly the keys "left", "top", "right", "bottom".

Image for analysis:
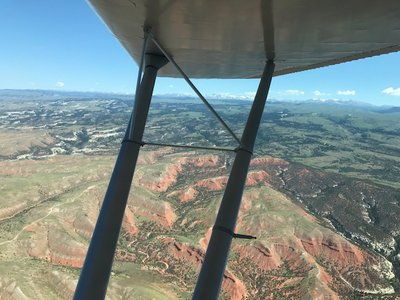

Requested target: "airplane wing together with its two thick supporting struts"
[{"left": 74, "top": 0, "right": 400, "bottom": 300}]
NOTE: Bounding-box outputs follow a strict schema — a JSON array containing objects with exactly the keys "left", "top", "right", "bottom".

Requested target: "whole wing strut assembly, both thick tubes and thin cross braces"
[{"left": 74, "top": 29, "right": 275, "bottom": 300}]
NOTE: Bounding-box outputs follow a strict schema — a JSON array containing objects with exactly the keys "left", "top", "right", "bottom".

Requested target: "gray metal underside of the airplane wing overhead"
[{"left": 89, "top": 0, "right": 400, "bottom": 78}]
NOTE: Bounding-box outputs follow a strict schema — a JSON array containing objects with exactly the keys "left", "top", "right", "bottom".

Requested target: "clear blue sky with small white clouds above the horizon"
[{"left": 0, "top": 0, "right": 400, "bottom": 106}]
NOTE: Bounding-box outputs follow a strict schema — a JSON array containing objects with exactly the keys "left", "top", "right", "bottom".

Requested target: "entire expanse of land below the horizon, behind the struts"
[{"left": 0, "top": 91, "right": 400, "bottom": 300}]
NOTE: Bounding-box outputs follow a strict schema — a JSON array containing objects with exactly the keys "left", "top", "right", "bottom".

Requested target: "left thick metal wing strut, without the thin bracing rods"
[{"left": 74, "top": 54, "right": 168, "bottom": 300}]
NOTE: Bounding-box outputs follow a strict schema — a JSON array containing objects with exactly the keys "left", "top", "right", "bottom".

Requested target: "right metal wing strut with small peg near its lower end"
[{"left": 192, "top": 61, "right": 275, "bottom": 300}]
